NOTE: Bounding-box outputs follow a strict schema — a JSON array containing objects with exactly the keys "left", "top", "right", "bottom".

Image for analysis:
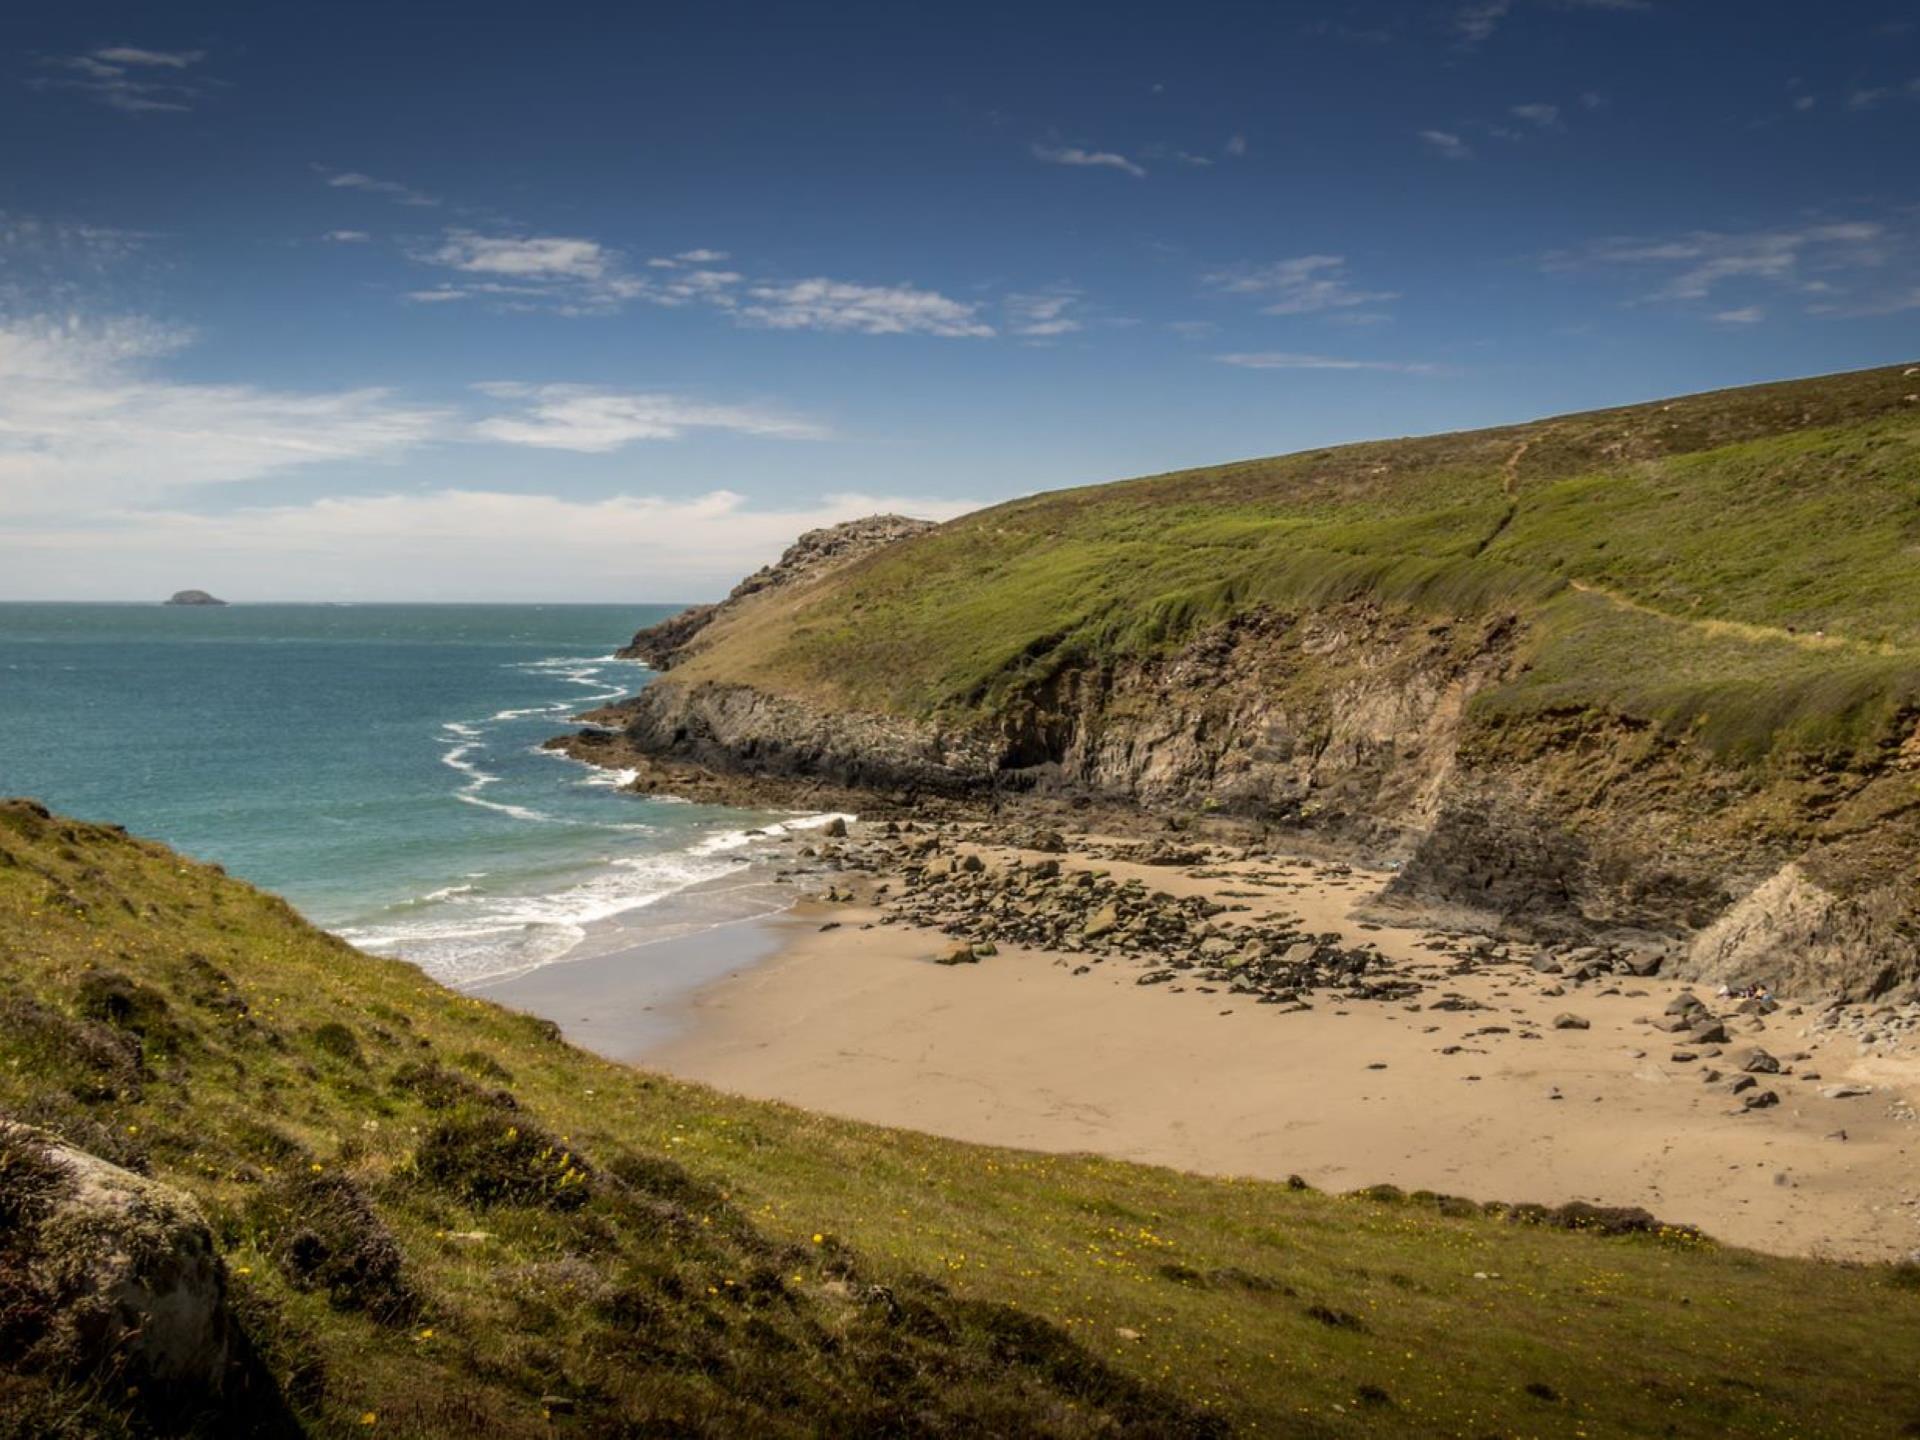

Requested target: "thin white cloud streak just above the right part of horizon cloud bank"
[{"left": 472, "top": 380, "right": 828, "bottom": 455}]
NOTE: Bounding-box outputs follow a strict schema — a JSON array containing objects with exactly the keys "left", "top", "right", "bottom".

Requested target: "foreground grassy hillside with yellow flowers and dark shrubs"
[{"left": 0, "top": 803, "right": 1920, "bottom": 1438}]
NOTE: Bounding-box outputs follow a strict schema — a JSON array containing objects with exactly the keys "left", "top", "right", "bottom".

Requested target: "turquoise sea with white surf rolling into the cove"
[{"left": 0, "top": 605, "right": 817, "bottom": 983}]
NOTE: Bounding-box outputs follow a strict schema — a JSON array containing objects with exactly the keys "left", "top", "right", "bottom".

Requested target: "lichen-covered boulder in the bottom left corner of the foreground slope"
[{"left": 0, "top": 1121, "right": 246, "bottom": 1417}]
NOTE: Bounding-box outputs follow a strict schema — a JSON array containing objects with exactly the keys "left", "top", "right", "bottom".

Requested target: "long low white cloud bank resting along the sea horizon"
[{"left": 0, "top": 490, "right": 977, "bottom": 603}]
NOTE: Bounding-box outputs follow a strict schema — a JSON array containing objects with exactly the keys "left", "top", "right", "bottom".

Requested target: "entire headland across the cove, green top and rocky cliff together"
[{"left": 576, "top": 369, "right": 1920, "bottom": 996}]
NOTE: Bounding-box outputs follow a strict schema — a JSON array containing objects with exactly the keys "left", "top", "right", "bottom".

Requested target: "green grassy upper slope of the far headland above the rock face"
[{"left": 684, "top": 369, "right": 1920, "bottom": 764}]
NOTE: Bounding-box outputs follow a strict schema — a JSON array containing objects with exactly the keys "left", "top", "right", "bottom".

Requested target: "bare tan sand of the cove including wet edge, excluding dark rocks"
[{"left": 493, "top": 829, "right": 1920, "bottom": 1260}]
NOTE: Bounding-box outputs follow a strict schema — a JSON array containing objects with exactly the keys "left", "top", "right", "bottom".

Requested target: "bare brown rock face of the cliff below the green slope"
[{"left": 579, "top": 545, "right": 1920, "bottom": 998}]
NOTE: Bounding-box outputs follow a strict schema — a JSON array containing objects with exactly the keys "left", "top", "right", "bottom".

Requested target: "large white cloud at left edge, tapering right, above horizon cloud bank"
[{"left": 0, "top": 317, "right": 442, "bottom": 515}]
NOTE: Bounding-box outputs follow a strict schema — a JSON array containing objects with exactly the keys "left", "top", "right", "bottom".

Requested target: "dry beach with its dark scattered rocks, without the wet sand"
[{"left": 625, "top": 806, "right": 1920, "bottom": 1256}]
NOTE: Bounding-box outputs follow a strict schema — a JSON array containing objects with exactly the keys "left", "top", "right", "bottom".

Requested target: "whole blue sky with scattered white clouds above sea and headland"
[{"left": 0, "top": 0, "right": 1920, "bottom": 603}]
